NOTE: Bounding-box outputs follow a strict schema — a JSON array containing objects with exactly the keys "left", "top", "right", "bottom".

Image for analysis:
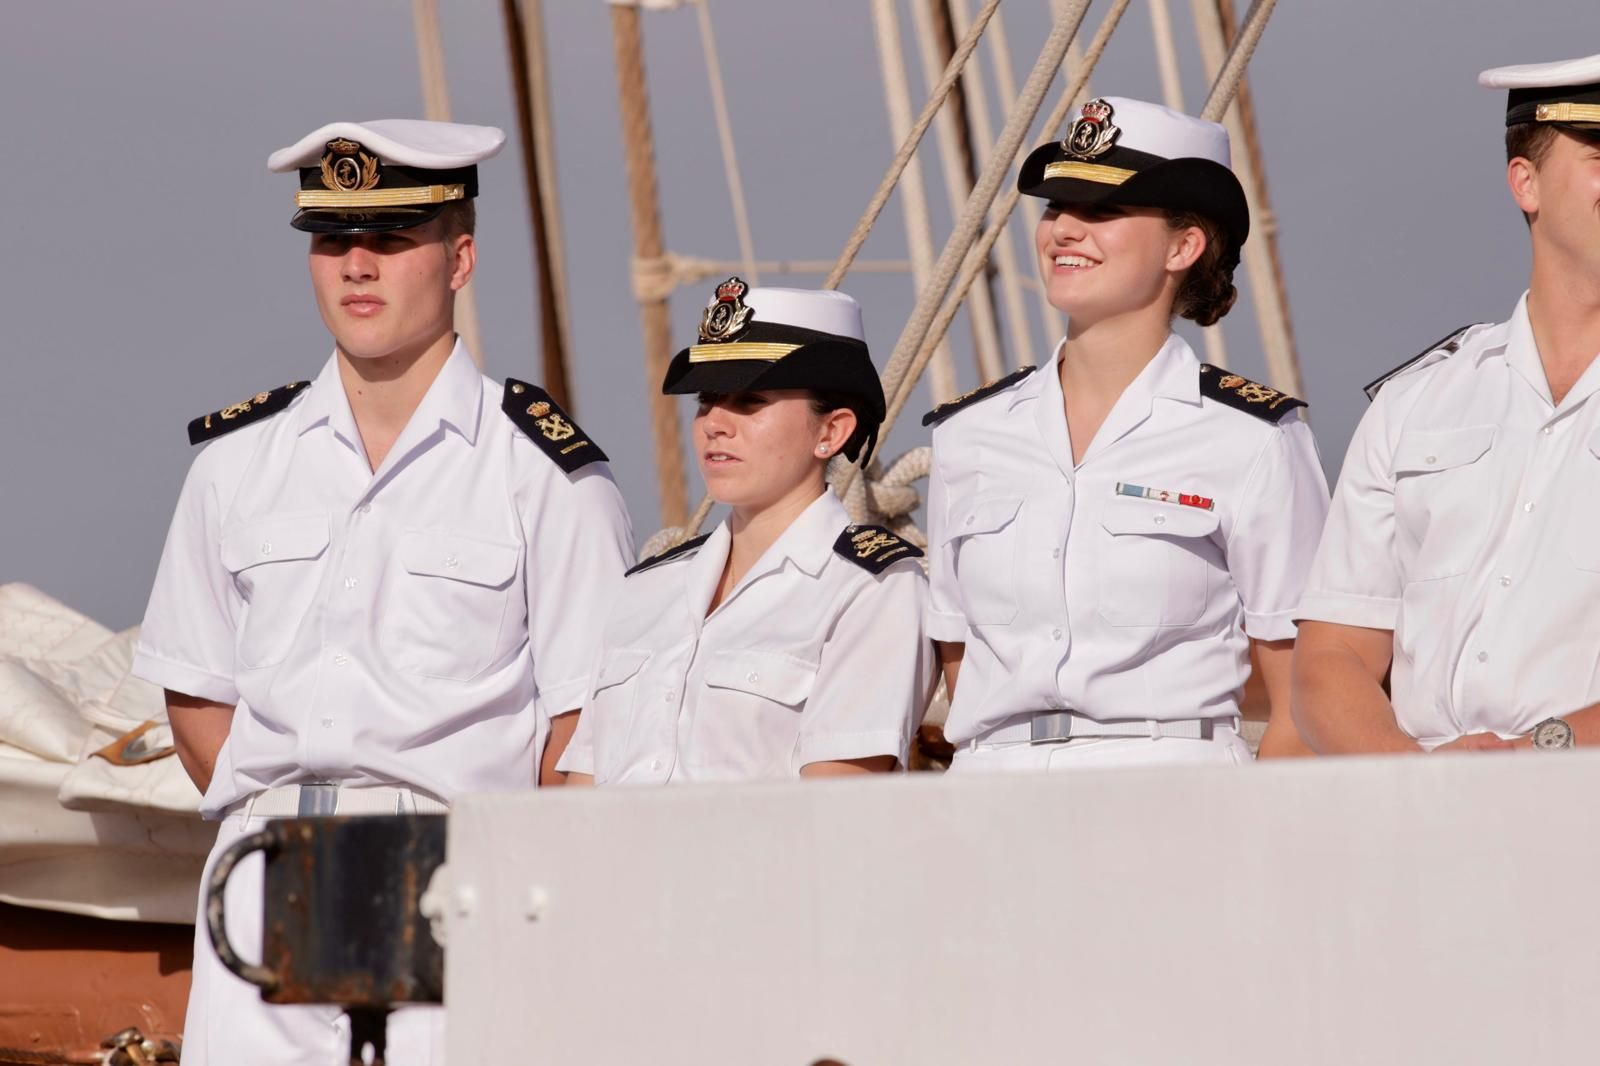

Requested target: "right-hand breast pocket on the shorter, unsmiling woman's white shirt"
[{"left": 688, "top": 650, "right": 816, "bottom": 773}]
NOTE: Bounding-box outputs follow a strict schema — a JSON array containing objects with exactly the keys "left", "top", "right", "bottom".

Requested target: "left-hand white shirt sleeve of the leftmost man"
[{"left": 131, "top": 448, "right": 243, "bottom": 704}]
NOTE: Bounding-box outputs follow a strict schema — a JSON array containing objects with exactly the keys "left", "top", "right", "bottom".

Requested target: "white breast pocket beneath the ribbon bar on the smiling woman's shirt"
[{"left": 1098, "top": 496, "right": 1218, "bottom": 626}]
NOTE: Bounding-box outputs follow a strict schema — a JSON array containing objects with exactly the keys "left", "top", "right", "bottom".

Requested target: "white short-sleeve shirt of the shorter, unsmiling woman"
[{"left": 560, "top": 490, "right": 933, "bottom": 784}]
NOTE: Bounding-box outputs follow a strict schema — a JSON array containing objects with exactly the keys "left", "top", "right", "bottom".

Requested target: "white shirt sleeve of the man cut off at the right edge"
[{"left": 1294, "top": 398, "right": 1405, "bottom": 631}]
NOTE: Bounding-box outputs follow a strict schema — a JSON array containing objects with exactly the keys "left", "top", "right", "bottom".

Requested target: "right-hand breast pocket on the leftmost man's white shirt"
[{"left": 376, "top": 530, "right": 522, "bottom": 680}]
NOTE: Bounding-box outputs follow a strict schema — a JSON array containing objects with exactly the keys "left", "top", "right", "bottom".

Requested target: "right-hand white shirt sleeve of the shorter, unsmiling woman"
[{"left": 794, "top": 563, "right": 933, "bottom": 771}]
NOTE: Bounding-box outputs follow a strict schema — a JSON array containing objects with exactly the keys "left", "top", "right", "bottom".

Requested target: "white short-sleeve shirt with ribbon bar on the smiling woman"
[{"left": 928, "top": 335, "right": 1328, "bottom": 742}]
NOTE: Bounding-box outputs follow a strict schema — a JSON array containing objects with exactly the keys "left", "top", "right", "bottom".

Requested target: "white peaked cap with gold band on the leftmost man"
[{"left": 267, "top": 118, "right": 506, "bottom": 234}]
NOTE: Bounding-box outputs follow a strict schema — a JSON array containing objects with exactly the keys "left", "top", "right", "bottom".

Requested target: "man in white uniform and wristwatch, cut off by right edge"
[{"left": 1293, "top": 56, "right": 1600, "bottom": 752}]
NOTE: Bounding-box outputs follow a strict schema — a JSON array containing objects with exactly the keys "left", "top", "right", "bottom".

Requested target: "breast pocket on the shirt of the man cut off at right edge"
[{"left": 1394, "top": 426, "right": 1494, "bottom": 581}]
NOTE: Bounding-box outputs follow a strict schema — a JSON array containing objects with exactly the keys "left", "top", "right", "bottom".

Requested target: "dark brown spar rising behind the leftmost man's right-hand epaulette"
[{"left": 501, "top": 0, "right": 578, "bottom": 411}]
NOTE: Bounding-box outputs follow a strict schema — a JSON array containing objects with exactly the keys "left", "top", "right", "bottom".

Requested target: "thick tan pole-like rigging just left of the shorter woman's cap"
[{"left": 610, "top": 3, "right": 688, "bottom": 525}]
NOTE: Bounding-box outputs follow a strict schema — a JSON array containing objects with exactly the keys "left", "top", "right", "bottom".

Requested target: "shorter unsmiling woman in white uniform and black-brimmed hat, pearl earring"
[{"left": 560, "top": 277, "right": 934, "bottom": 784}]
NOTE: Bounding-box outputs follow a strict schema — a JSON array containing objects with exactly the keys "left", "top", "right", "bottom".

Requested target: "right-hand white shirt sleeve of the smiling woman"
[{"left": 1227, "top": 416, "right": 1328, "bottom": 640}]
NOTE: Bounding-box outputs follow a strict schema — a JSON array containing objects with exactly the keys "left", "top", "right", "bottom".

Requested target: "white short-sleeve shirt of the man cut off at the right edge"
[{"left": 1296, "top": 296, "right": 1600, "bottom": 747}]
